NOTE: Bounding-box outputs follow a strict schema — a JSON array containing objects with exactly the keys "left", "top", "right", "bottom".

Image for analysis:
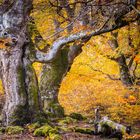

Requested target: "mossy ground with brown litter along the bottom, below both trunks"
[{"left": 0, "top": 116, "right": 140, "bottom": 140}]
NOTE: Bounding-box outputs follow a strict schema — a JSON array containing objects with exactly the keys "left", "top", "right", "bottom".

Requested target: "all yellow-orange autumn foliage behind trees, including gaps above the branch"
[{"left": 32, "top": 0, "right": 140, "bottom": 123}]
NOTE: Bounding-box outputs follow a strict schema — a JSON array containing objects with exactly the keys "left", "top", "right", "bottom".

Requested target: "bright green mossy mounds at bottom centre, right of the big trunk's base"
[{"left": 27, "top": 115, "right": 93, "bottom": 140}]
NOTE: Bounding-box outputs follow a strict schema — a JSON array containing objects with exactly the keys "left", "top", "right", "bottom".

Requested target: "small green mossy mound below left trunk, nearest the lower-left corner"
[{"left": 5, "top": 126, "right": 24, "bottom": 135}]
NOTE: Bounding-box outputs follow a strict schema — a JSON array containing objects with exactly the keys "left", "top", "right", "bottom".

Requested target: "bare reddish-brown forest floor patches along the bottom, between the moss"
[{"left": 0, "top": 118, "right": 140, "bottom": 140}]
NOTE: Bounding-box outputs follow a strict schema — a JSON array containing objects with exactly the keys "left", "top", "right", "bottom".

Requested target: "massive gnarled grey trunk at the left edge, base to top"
[{"left": 0, "top": 0, "right": 39, "bottom": 125}]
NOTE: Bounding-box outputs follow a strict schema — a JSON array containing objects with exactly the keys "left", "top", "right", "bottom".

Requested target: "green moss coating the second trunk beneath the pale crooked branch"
[{"left": 40, "top": 49, "right": 68, "bottom": 117}]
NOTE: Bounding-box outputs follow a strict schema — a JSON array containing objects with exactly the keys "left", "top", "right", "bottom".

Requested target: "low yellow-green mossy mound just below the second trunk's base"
[{"left": 58, "top": 117, "right": 77, "bottom": 125}]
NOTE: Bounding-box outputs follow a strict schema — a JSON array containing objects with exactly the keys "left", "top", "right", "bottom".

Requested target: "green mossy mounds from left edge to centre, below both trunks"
[{"left": 0, "top": 114, "right": 93, "bottom": 140}]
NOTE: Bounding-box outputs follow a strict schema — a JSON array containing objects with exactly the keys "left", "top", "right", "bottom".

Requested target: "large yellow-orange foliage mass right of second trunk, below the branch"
[{"left": 59, "top": 25, "right": 140, "bottom": 123}]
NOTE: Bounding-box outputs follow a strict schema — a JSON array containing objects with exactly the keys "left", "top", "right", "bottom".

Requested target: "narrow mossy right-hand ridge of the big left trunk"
[{"left": 23, "top": 43, "right": 41, "bottom": 122}]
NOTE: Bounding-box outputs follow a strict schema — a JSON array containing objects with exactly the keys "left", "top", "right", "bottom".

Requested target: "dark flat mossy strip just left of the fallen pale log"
[{"left": 75, "top": 127, "right": 94, "bottom": 135}]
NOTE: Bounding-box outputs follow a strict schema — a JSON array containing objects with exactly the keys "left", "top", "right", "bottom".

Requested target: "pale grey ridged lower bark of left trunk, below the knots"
[{"left": 0, "top": 48, "right": 27, "bottom": 125}]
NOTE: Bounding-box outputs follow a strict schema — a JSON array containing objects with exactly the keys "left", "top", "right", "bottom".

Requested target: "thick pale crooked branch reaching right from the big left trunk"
[{"left": 36, "top": 15, "right": 136, "bottom": 62}]
